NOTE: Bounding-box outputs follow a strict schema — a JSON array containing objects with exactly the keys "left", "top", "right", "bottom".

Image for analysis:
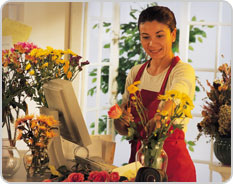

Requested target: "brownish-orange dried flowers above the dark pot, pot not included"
[{"left": 197, "top": 64, "right": 231, "bottom": 139}]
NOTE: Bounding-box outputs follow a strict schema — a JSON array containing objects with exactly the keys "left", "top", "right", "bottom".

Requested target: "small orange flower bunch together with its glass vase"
[{"left": 15, "top": 115, "right": 58, "bottom": 176}]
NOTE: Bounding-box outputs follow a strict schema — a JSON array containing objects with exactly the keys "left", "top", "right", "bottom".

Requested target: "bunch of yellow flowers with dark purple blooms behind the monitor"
[{"left": 26, "top": 47, "right": 89, "bottom": 107}]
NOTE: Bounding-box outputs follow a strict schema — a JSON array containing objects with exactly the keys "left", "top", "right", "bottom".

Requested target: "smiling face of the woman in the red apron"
[{"left": 139, "top": 21, "right": 176, "bottom": 59}]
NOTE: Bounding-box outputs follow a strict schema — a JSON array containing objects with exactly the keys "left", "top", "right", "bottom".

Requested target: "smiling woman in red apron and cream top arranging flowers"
[{"left": 114, "top": 6, "right": 196, "bottom": 182}]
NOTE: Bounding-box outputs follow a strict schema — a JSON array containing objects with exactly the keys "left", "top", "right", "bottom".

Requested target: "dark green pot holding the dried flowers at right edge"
[{"left": 214, "top": 137, "right": 231, "bottom": 165}]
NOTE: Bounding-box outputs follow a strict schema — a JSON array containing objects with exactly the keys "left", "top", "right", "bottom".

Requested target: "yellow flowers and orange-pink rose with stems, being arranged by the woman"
[{"left": 108, "top": 81, "right": 194, "bottom": 168}]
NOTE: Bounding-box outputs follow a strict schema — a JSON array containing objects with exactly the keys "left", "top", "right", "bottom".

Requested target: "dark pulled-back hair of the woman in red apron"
[{"left": 138, "top": 6, "right": 176, "bottom": 32}]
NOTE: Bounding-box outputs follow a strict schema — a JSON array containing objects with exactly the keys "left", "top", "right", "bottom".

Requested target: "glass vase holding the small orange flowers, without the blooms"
[{"left": 23, "top": 148, "right": 49, "bottom": 177}]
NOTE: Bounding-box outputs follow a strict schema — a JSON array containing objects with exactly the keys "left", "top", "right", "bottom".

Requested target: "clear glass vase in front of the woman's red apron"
[{"left": 136, "top": 142, "right": 168, "bottom": 182}]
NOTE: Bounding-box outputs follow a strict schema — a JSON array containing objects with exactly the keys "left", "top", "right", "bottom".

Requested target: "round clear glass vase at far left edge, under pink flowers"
[{"left": 2, "top": 145, "right": 21, "bottom": 178}]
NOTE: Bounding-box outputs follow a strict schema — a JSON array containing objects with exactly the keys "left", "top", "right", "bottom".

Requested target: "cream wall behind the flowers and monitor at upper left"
[{"left": 2, "top": 2, "right": 82, "bottom": 149}]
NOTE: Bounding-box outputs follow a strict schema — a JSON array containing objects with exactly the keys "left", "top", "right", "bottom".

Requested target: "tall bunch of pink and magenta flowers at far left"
[{"left": 2, "top": 42, "right": 37, "bottom": 146}]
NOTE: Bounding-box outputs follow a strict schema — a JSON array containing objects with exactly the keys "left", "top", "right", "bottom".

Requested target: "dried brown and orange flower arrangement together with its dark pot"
[{"left": 197, "top": 63, "right": 231, "bottom": 165}]
